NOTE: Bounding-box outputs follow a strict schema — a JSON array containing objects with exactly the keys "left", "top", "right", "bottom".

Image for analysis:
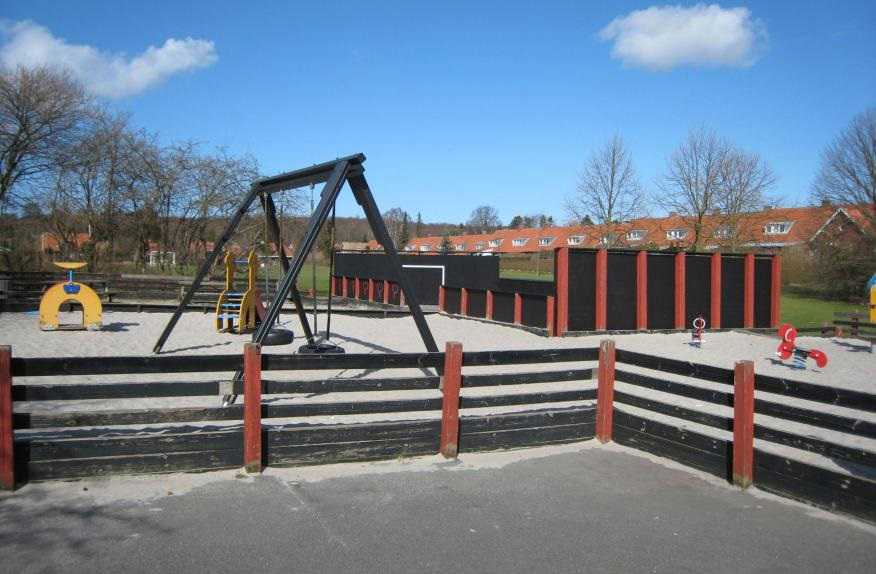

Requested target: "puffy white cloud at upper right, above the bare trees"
[{"left": 599, "top": 4, "right": 766, "bottom": 70}]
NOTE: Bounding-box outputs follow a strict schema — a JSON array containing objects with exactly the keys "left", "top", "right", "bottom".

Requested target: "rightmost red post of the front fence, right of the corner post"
[{"left": 733, "top": 361, "right": 754, "bottom": 488}]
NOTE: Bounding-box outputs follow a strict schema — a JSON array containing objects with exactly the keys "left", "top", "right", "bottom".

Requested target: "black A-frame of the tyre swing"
[{"left": 153, "top": 153, "right": 438, "bottom": 353}]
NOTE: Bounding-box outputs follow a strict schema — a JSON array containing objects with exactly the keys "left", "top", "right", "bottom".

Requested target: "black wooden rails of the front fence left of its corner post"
[{"left": 0, "top": 347, "right": 597, "bottom": 483}]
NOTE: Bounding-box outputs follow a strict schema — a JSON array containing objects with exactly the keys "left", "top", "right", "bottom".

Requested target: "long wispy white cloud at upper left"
[{"left": 0, "top": 21, "right": 217, "bottom": 98}]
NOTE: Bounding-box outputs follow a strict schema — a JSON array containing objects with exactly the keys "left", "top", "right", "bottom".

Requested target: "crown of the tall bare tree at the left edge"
[{"left": 0, "top": 68, "right": 89, "bottom": 207}]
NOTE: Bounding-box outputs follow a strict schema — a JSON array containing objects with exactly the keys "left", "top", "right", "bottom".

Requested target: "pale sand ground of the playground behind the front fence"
[{"left": 0, "top": 311, "right": 876, "bottom": 482}]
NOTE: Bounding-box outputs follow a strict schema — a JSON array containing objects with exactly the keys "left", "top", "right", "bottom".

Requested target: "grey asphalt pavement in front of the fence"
[{"left": 0, "top": 446, "right": 876, "bottom": 574}]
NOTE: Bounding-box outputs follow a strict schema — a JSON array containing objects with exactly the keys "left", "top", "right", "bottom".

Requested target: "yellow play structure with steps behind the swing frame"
[{"left": 216, "top": 250, "right": 265, "bottom": 333}]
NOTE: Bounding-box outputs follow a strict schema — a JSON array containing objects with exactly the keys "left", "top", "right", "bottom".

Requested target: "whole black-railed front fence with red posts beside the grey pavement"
[{"left": 0, "top": 340, "right": 876, "bottom": 521}]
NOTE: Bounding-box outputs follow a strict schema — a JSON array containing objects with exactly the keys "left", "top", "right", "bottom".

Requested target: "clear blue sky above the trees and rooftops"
[{"left": 0, "top": 0, "right": 876, "bottom": 222}]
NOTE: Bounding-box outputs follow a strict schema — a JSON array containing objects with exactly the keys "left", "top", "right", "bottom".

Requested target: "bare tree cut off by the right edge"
[{"left": 813, "top": 108, "right": 876, "bottom": 232}]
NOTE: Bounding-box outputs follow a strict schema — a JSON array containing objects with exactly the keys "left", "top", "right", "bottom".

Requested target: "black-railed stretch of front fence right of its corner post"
[{"left": 597, "top": 344, "right": 876, "bottom": 521}]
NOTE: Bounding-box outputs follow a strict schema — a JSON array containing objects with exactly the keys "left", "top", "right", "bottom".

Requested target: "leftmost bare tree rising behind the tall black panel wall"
[{"left": 566, "top": 135, "right": 645, "bottom": 246}]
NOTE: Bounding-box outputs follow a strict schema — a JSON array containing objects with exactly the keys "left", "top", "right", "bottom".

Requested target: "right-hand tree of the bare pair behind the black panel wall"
[{"left": 715, "top": 148, "right": 776, "bottom": 248}]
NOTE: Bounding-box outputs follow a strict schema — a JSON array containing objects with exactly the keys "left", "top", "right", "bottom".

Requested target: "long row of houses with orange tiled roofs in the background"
[{"left": 368, "top": 205, "right": 868, "bottom": 253}]
